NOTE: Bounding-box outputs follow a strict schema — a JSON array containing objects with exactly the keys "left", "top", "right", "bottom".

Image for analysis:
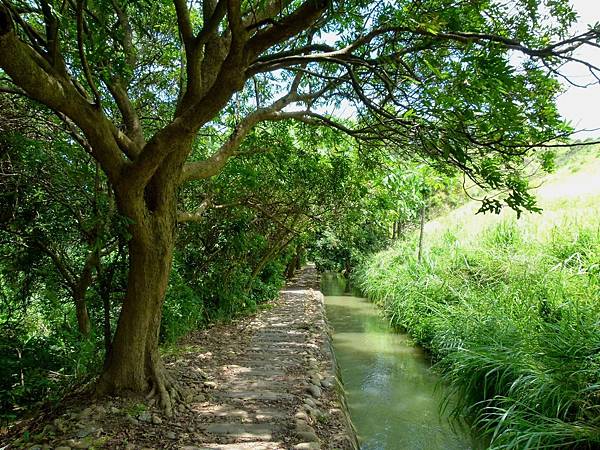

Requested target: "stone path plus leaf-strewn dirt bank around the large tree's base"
[{"left": 5, "top": 266, "right": 358, "bottom": 450}]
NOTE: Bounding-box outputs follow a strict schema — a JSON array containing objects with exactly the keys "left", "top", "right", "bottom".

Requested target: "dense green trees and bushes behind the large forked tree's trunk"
[{"left": 0, "top": 100, "right": 387, "bottom": 418}]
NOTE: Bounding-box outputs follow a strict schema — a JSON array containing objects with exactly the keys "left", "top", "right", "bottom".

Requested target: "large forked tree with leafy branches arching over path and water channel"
[{"left": 0, "top": 0, "right": 600, "bottom": 412}]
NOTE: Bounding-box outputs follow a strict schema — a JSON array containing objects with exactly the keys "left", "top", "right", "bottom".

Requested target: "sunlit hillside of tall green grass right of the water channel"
[{"left": 357, "top": 148, "right": 600, "bottom": 449}]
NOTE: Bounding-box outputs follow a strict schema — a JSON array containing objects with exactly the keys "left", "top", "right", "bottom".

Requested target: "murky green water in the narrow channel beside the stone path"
[{"left": 322, "top": 274, "right": 478, "bottom": 450}]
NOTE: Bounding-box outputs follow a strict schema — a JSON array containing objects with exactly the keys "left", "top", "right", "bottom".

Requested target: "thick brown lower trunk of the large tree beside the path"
[{"left": 96, "top": 206, "right": 178, "bottom": 415}]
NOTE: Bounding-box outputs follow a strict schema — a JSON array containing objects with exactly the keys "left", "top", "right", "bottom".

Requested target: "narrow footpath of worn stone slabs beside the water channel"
[{"left": 172, "top": 267, "right": 340, "bottom": 450}]
